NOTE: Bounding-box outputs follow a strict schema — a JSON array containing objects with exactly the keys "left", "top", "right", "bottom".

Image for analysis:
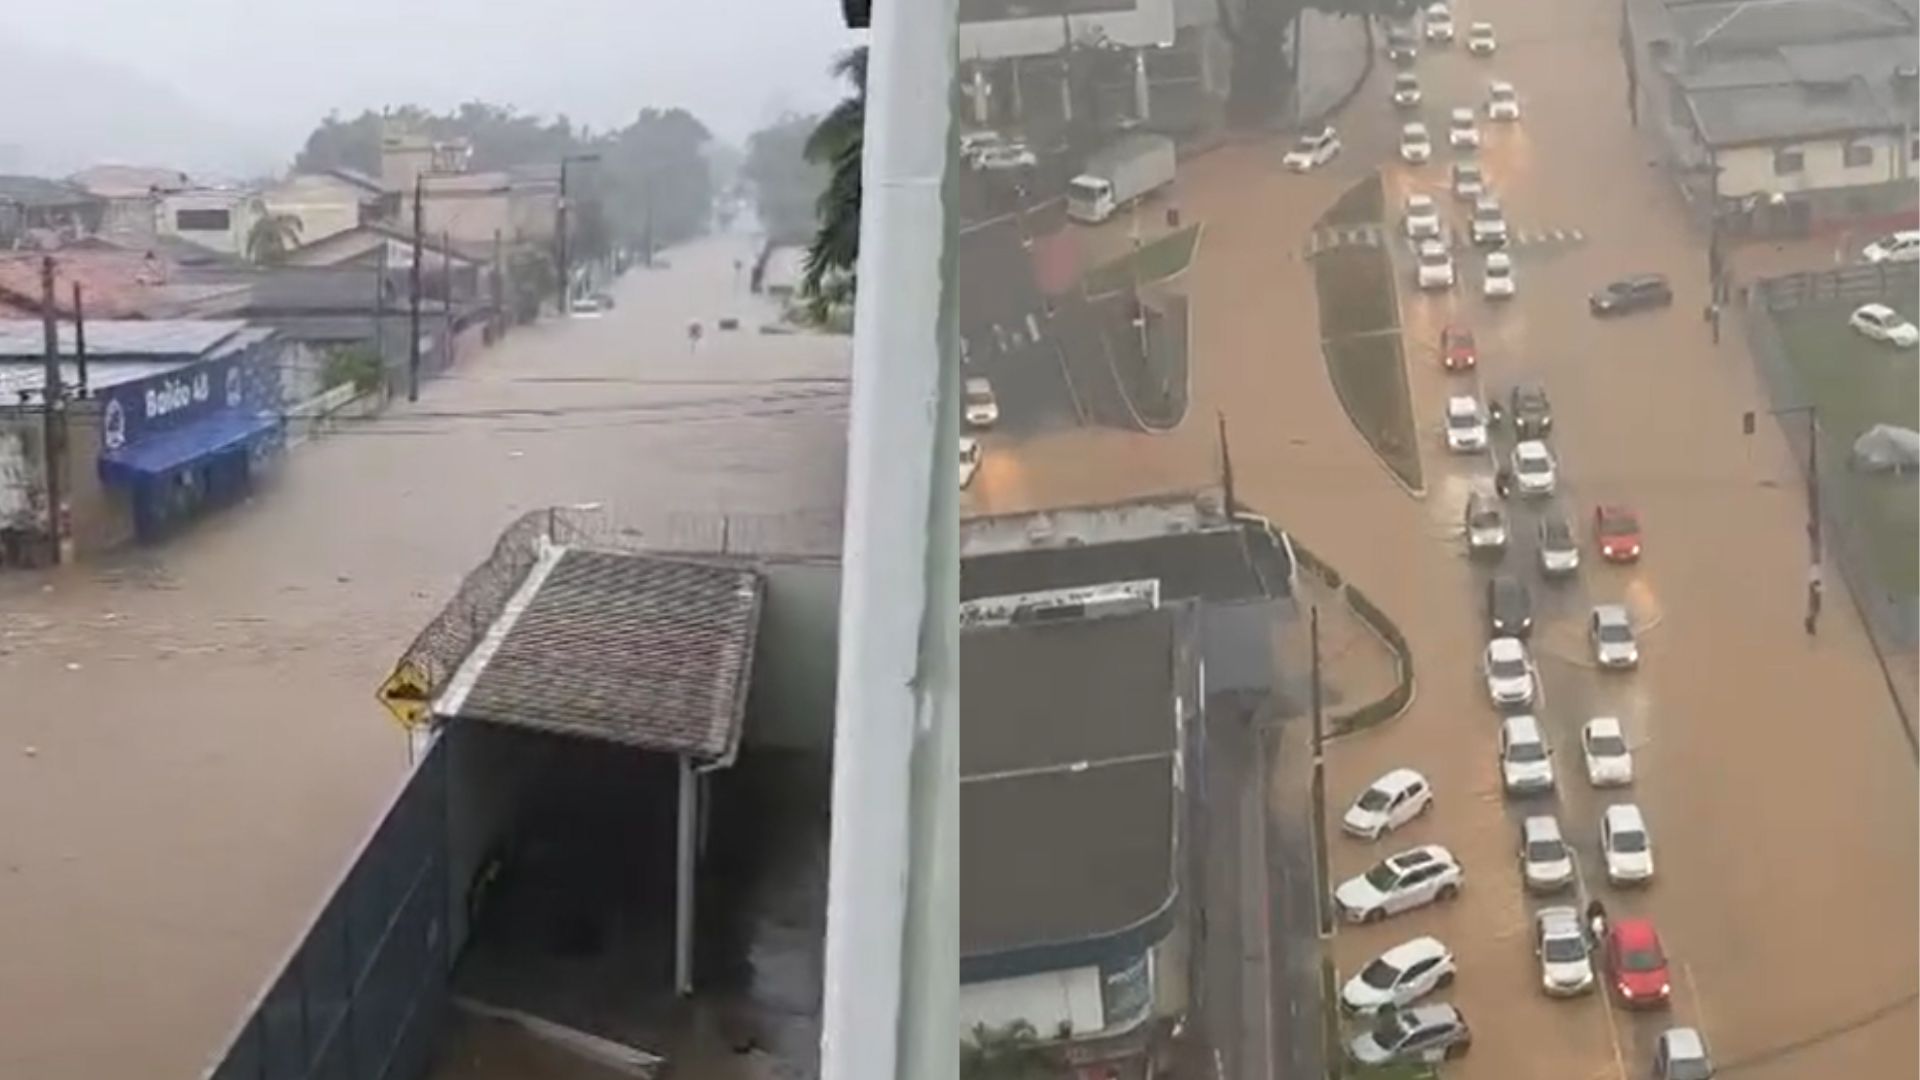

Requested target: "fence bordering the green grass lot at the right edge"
[{"left": 1745, "top": 294, "right": 1920, "bottom": 734}]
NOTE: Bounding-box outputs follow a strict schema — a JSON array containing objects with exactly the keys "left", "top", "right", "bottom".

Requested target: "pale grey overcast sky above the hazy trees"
[{"left": 0, "top": 0, "right": 856, "bottom": 165}]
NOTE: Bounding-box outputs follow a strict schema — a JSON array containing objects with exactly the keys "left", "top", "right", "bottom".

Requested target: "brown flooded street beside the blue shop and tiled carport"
[{"left": 0, "top": 236, "right": 847, "bottom": 1080}]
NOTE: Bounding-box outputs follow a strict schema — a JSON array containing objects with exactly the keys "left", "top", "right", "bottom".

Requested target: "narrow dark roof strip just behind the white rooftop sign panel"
[{"left": 960, "top": 528, "right": 1286, "bottom": 601}]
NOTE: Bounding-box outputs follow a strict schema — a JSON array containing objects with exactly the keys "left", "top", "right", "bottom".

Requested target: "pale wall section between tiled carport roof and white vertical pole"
[{"left": 745, "top": 559, "right": 841, "bottom": 751}]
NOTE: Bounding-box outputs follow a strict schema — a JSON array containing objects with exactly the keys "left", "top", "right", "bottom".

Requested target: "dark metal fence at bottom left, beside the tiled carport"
[{"left": 207, "top": 740, "right": 449, "bottom": 1080}]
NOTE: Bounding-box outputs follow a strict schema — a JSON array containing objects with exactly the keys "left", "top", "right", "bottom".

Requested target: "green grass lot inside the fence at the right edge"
[{"left": 1776, "top": 298, "right": 1920, "bottom": 596}]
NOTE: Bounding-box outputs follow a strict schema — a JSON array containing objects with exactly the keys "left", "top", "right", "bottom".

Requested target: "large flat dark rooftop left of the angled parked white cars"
[{"left": 960, "top": 609, "right": 1179, "bottom": 957}]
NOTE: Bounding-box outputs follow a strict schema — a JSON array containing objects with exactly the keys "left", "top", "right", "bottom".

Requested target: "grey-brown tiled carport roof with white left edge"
[{"left": 436, "top": 548, "right": 764, "bottom": 759}]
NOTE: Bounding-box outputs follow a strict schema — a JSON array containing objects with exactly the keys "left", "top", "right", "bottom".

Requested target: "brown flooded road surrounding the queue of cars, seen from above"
[{"left": 970, "top": 0, "right": 1920, "bottom": 1080}]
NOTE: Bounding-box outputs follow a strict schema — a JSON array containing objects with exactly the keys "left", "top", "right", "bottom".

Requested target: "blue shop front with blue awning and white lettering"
[{"left": 98, "top": 344, "right": 284, "bottom": 542}]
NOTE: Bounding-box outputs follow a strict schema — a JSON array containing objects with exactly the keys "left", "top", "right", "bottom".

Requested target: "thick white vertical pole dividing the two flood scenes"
[{"left": 820, "top": 0, "right": 960, "bottom": 1080}]
